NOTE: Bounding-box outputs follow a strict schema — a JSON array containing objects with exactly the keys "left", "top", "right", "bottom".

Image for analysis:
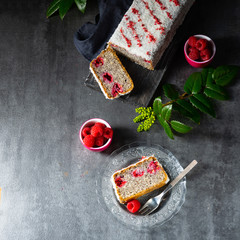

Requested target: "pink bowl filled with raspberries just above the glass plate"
[{"left": 79, "top": 118, "right": 113, "bottom": 152}]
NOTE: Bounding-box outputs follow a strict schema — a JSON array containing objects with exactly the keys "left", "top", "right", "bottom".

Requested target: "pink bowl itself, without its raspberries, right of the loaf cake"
[{"left": 184, "top": 34, "right": 216, "bottom": 68}]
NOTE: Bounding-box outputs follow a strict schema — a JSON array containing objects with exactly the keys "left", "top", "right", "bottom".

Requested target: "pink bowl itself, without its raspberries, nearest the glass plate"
[{"left": 79, "top": 118, "right": 112, "bottom": 152}]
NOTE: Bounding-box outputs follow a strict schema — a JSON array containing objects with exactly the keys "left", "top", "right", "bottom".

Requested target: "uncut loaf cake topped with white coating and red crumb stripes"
[{"left": 108, "top": 0, "right": 194, "bottom": 70}]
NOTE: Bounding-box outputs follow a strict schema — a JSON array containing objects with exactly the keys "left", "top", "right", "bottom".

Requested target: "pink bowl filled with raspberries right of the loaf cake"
[{"left": 184, "top": 34, "right": 216, "bottom": 68}]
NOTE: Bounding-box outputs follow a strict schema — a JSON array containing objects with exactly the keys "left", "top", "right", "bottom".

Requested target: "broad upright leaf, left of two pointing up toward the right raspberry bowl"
[{"left": 184, "top": 72, "right": 202, "bottom": 94}]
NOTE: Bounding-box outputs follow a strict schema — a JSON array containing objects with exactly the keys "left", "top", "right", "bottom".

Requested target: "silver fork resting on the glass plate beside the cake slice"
[{"left": 139, "top": 160, "right": 198, "bottom": 215}]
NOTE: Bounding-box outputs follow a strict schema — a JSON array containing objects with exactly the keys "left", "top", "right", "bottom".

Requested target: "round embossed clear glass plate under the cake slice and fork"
[{"left": 97, "top": 142, "right": 186, "bottom": 230}]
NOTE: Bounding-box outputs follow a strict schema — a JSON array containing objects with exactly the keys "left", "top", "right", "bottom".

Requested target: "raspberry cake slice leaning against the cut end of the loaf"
[{"left": 90, "top": 47, "right": 134, "bottom": 99}]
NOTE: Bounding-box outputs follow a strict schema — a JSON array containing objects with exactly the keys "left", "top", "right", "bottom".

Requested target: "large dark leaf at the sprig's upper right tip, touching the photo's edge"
[{"left": 213, "top": 65, "right": 239, "bottom": 86}]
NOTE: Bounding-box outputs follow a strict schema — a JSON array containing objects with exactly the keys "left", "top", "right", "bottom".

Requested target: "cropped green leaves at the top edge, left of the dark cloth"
[{"left": 47, "top": 0, "right": 87, "bottom": 20}]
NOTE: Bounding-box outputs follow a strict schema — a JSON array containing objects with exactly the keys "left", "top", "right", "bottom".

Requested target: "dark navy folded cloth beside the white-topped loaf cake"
[{"left": 74, "top": 0, "right": 133, "bottom": 61}]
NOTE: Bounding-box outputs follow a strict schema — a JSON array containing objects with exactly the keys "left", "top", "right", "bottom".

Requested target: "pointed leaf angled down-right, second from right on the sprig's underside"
[{"left": 189, "top": 94, "right": 216, "bottom": 117}]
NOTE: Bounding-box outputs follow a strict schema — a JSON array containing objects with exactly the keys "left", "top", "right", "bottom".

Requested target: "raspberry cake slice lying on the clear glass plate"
[{"left": 111, "top": 156, "right": 169, "bottom": 203}]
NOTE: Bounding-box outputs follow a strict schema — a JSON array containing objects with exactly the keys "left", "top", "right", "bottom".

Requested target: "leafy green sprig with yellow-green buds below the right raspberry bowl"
[{"left": 133, "top": 65, "right": 239, "bottom": 139}]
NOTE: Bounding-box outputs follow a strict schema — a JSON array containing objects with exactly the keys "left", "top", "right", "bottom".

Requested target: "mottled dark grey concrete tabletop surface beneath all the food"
[{"left": 0, "top": 0, "right": 240, "bottom": 240}]
